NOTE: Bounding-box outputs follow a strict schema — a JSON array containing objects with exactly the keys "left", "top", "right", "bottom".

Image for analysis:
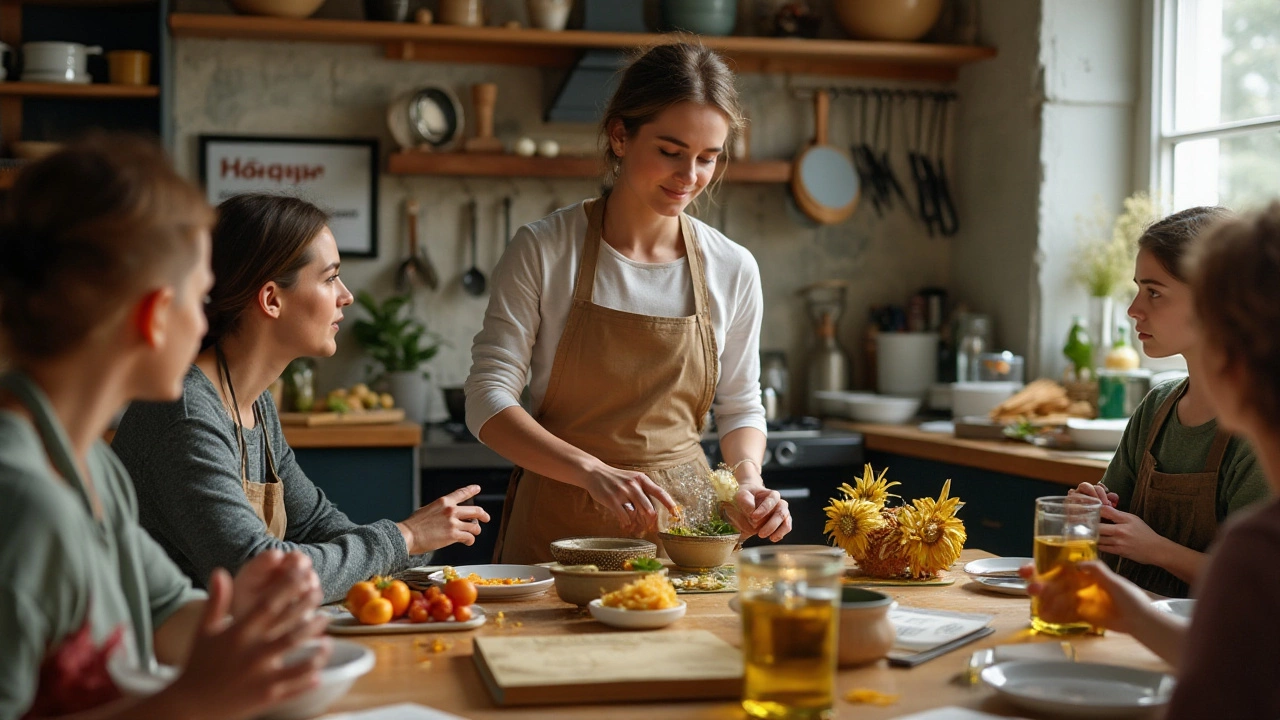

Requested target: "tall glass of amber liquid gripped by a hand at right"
[{"left": 1032, "top": 495, "right": 1102, "bottom": 635}]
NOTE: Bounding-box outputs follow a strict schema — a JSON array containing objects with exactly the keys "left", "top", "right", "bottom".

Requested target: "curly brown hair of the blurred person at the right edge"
[{"left": 1185, "top": 201, "right": 1280, "bottom": 428}]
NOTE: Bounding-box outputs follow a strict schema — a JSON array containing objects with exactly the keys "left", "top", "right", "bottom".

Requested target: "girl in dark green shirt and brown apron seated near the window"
[{"left": 1073, "top": 208, "right": 1270, "bottom": 597}]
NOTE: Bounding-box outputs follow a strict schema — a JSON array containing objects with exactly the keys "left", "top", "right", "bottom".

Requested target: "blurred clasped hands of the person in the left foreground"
[{"left": 162, "top": 551, "right": 330, "bottom": 719}]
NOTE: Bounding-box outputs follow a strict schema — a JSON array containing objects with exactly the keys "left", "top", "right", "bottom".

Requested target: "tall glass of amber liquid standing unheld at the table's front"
[{"left": 737, "top": 546, "right": 845, "bottom": 720}]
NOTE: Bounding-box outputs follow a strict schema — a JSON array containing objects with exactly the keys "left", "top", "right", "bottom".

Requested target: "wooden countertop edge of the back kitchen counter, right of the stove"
[{"left": 826, "top": 420, "right": 1107, "bottom": 487}]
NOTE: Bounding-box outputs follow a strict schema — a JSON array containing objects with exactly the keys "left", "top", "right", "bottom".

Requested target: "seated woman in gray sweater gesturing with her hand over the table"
[{"left": 113, "top": 193, "right": 489, "bottom": 602}]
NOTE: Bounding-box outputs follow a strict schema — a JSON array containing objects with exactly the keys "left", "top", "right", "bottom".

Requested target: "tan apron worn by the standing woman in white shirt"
[{"left": 494, "top": 194, "right": 718, "bottom": 564}]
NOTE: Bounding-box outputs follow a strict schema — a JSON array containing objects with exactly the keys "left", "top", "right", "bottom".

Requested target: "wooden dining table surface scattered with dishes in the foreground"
[{"left": 332, "top": 550, "right": 1167, "bottom": 720}]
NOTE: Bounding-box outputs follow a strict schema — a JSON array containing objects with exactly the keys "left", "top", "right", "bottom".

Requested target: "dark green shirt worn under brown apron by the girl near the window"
[{"left": 1102, "top": 380, "right": 1271, "bottom": 520}]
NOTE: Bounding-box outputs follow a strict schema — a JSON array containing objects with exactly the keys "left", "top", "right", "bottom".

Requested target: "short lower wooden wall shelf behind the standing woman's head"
[{"left": 387, "top": 150, "right": 791, "bottom": 183}]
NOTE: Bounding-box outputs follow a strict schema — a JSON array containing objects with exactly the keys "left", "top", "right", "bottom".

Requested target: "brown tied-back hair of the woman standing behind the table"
[{"left": 600, "top": 42, "right": 746, "bottom": 183}]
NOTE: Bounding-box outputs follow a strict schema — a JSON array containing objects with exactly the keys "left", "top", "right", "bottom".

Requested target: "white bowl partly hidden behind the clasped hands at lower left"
[{"left": 108, "top": 639, "right": 374, "bottom": 720}]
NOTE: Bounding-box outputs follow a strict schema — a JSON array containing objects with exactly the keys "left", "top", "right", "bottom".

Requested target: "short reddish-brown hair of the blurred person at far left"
[{"left": 0, "top": 133, "right": 214, "bottom": 361}]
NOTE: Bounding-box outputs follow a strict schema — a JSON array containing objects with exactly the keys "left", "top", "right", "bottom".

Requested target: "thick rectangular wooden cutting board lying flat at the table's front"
[{"left": 472, "top": 630, "right": 742, "bottom": 706}]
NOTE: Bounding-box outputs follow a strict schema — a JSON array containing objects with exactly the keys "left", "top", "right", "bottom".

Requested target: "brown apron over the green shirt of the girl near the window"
[{"left": 1106, "top": 382, "right": 1231, "bottom": 597}]
